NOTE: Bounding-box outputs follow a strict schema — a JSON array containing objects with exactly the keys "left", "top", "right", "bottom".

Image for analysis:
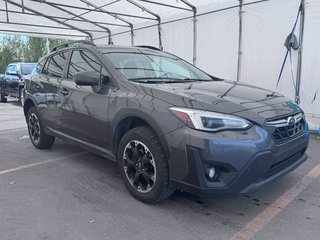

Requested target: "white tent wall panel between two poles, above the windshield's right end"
[{"left": 197, "top": 5, "right": 239, "bottom": 80}]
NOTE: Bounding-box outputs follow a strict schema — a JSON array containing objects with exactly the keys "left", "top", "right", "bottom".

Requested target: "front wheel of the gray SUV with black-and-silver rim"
[{"left": 117, "top": 127, "right": 173, "bottom": 203}]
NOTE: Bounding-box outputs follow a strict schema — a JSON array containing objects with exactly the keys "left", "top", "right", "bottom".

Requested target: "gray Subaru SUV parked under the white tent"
[{"left": 24, "top": 41, "right": 309, "bottom": 203}]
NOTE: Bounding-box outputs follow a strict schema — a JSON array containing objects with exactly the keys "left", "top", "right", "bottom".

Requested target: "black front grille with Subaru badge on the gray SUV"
[{"left": 266, "top": 113, "right": 306, "bottom": 143}]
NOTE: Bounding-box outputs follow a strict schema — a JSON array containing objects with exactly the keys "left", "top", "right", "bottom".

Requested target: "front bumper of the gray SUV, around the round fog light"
[{"left": 167, "top": 123, "right": 309, "bottom": 195}]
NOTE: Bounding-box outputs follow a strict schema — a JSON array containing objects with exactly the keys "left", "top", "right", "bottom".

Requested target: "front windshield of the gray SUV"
[{"left": 104, "top": 52, "right": 212, "bottom": 83}]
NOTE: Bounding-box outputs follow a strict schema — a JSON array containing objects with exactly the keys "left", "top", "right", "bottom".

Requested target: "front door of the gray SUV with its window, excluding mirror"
[{"left": 60, "top": 49, "right": 114, "bottom": 149}]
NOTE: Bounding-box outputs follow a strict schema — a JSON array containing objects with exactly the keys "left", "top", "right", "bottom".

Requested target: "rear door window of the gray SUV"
[{"left": 42, "top": 52, "right": 68, "bottom": 78}]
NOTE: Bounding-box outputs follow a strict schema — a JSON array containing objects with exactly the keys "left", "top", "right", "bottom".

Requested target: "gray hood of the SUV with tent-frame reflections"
[{"left": 141, "top": 81, "right": 301, "bottom": 122}]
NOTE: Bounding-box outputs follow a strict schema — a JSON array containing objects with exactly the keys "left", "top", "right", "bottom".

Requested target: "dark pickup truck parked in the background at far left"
[{"left": 0, "top": 62, "right": 36, "bottom": 105}]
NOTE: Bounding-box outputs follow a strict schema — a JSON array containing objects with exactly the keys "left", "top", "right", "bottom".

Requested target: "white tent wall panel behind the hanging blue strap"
[{"left": 240, "top": 0, "right": 300, "bottom": 100}]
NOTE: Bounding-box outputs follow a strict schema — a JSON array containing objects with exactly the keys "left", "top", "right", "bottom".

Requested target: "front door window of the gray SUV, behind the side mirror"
[{"left": 68, "top": 50, "right": 102, "bottom": 79}]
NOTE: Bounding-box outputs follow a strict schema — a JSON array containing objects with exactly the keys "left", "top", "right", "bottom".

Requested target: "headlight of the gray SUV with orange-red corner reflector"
[{"left": 169, "top": 107, "right": 252, "bottom": 132}]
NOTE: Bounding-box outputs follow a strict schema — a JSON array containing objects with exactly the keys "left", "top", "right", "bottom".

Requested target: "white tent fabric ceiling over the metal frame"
[{"left": 0, "top": 0, "right": 238, "bottom": 39}]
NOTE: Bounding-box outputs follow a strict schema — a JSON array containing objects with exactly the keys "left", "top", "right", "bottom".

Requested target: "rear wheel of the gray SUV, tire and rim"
[{"left": 27, "top": 107, "right": 55, "bottom": 149}]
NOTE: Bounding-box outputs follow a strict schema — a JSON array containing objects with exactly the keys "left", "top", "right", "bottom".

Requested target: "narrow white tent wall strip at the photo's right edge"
[{"left": 300, "top": 0, "right": 320, "bottom": 129}]
